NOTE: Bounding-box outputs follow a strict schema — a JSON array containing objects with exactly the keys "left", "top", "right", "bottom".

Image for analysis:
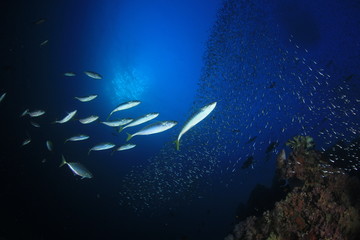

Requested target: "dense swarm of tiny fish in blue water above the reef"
[{"left": 119, "top": 0, "right": 360, "bottom": 211}]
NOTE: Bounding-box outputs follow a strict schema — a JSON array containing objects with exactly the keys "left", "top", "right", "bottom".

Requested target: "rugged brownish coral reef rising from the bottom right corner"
[{"left": 225, "top": 136, "right": 360, "bottom": 240}]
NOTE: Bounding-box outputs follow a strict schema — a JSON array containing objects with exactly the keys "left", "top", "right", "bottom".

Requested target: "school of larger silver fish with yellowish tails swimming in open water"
[{"left": 0, "top": 76, "right": 216, "bottom": 178}]
